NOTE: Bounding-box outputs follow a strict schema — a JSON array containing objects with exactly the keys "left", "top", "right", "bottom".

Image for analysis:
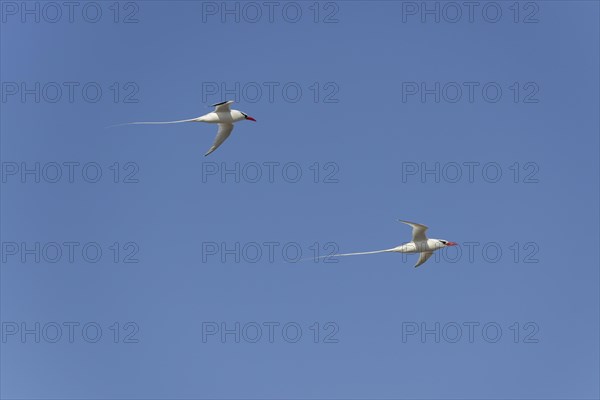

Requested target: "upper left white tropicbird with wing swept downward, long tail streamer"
[{"left": 114, "top": 100, "right": 256, "bottom": 157}]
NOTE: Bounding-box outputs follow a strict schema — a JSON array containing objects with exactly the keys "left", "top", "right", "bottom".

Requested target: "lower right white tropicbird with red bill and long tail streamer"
[{"left": 319, "top": 220, "right": 458, "bottom": 268}]
